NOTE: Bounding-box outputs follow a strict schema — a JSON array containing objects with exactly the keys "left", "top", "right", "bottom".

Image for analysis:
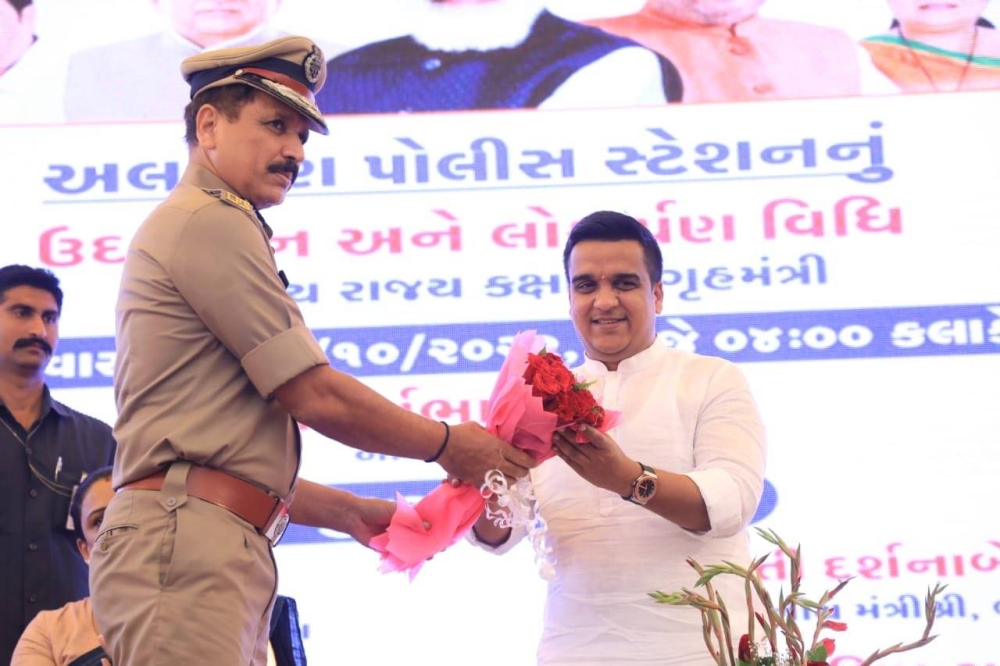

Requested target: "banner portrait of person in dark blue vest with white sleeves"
[{"left": 316, "top": 0, "right": 682, "bottom": 114}]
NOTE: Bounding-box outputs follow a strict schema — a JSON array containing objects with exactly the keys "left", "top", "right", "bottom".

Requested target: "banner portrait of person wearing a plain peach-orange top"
[{"left": 587, "top": 0, "right": 899, "bottom": 103}]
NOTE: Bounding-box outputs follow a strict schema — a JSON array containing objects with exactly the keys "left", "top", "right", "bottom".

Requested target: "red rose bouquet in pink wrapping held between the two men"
[{"left": 369, "top": 331, "right": 621, "bottom": 580}]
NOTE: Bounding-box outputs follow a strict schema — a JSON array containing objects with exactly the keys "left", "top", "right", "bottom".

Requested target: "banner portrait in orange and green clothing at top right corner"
[{"left": 861, "top": 0, "right": 1000, "bottom": 92}]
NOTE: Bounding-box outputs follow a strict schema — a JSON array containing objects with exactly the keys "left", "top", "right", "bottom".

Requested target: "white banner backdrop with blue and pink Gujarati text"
[{"left": 0, "top": 0, "right": 1000, "bottom": 666}]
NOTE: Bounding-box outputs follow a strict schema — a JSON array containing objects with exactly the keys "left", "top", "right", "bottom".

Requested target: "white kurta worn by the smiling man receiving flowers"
[{"left": 473, "top": 341, "right": 766, "bottom": 666}]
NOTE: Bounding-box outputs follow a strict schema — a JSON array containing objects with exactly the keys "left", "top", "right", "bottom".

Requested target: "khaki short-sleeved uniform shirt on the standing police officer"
[{"left": 113, "top": 165, "right": 328, "bottom": 499}]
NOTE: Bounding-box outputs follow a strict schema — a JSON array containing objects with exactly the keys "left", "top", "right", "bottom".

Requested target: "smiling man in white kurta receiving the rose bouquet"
[{"left": 470, "top": 211, "right": 766, "bottom": 666}]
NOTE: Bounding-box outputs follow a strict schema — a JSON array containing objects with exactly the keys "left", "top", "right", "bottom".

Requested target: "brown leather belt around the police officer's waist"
[{"left": 118, "top": 465, "right": 288, "bottom": 545}]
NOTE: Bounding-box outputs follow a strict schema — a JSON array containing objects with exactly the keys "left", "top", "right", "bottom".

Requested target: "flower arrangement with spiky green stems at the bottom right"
[{"left": 650, "top": 528, "right": 947, "bottom": 666}]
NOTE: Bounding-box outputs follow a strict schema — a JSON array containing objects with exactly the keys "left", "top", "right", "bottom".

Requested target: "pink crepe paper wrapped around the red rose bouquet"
[{"left": 369, "top": 331, "right": 621, "bottom": 580}]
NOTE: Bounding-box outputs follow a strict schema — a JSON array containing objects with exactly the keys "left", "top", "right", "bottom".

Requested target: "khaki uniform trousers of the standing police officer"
[{"left": 90, "top": 462, "right": 277, "bottom": 666}]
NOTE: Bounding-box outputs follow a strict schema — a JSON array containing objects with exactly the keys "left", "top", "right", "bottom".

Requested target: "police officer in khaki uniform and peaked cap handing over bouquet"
[{"left": 91, "top": 37, "right": 534, "bottom": 666}]
